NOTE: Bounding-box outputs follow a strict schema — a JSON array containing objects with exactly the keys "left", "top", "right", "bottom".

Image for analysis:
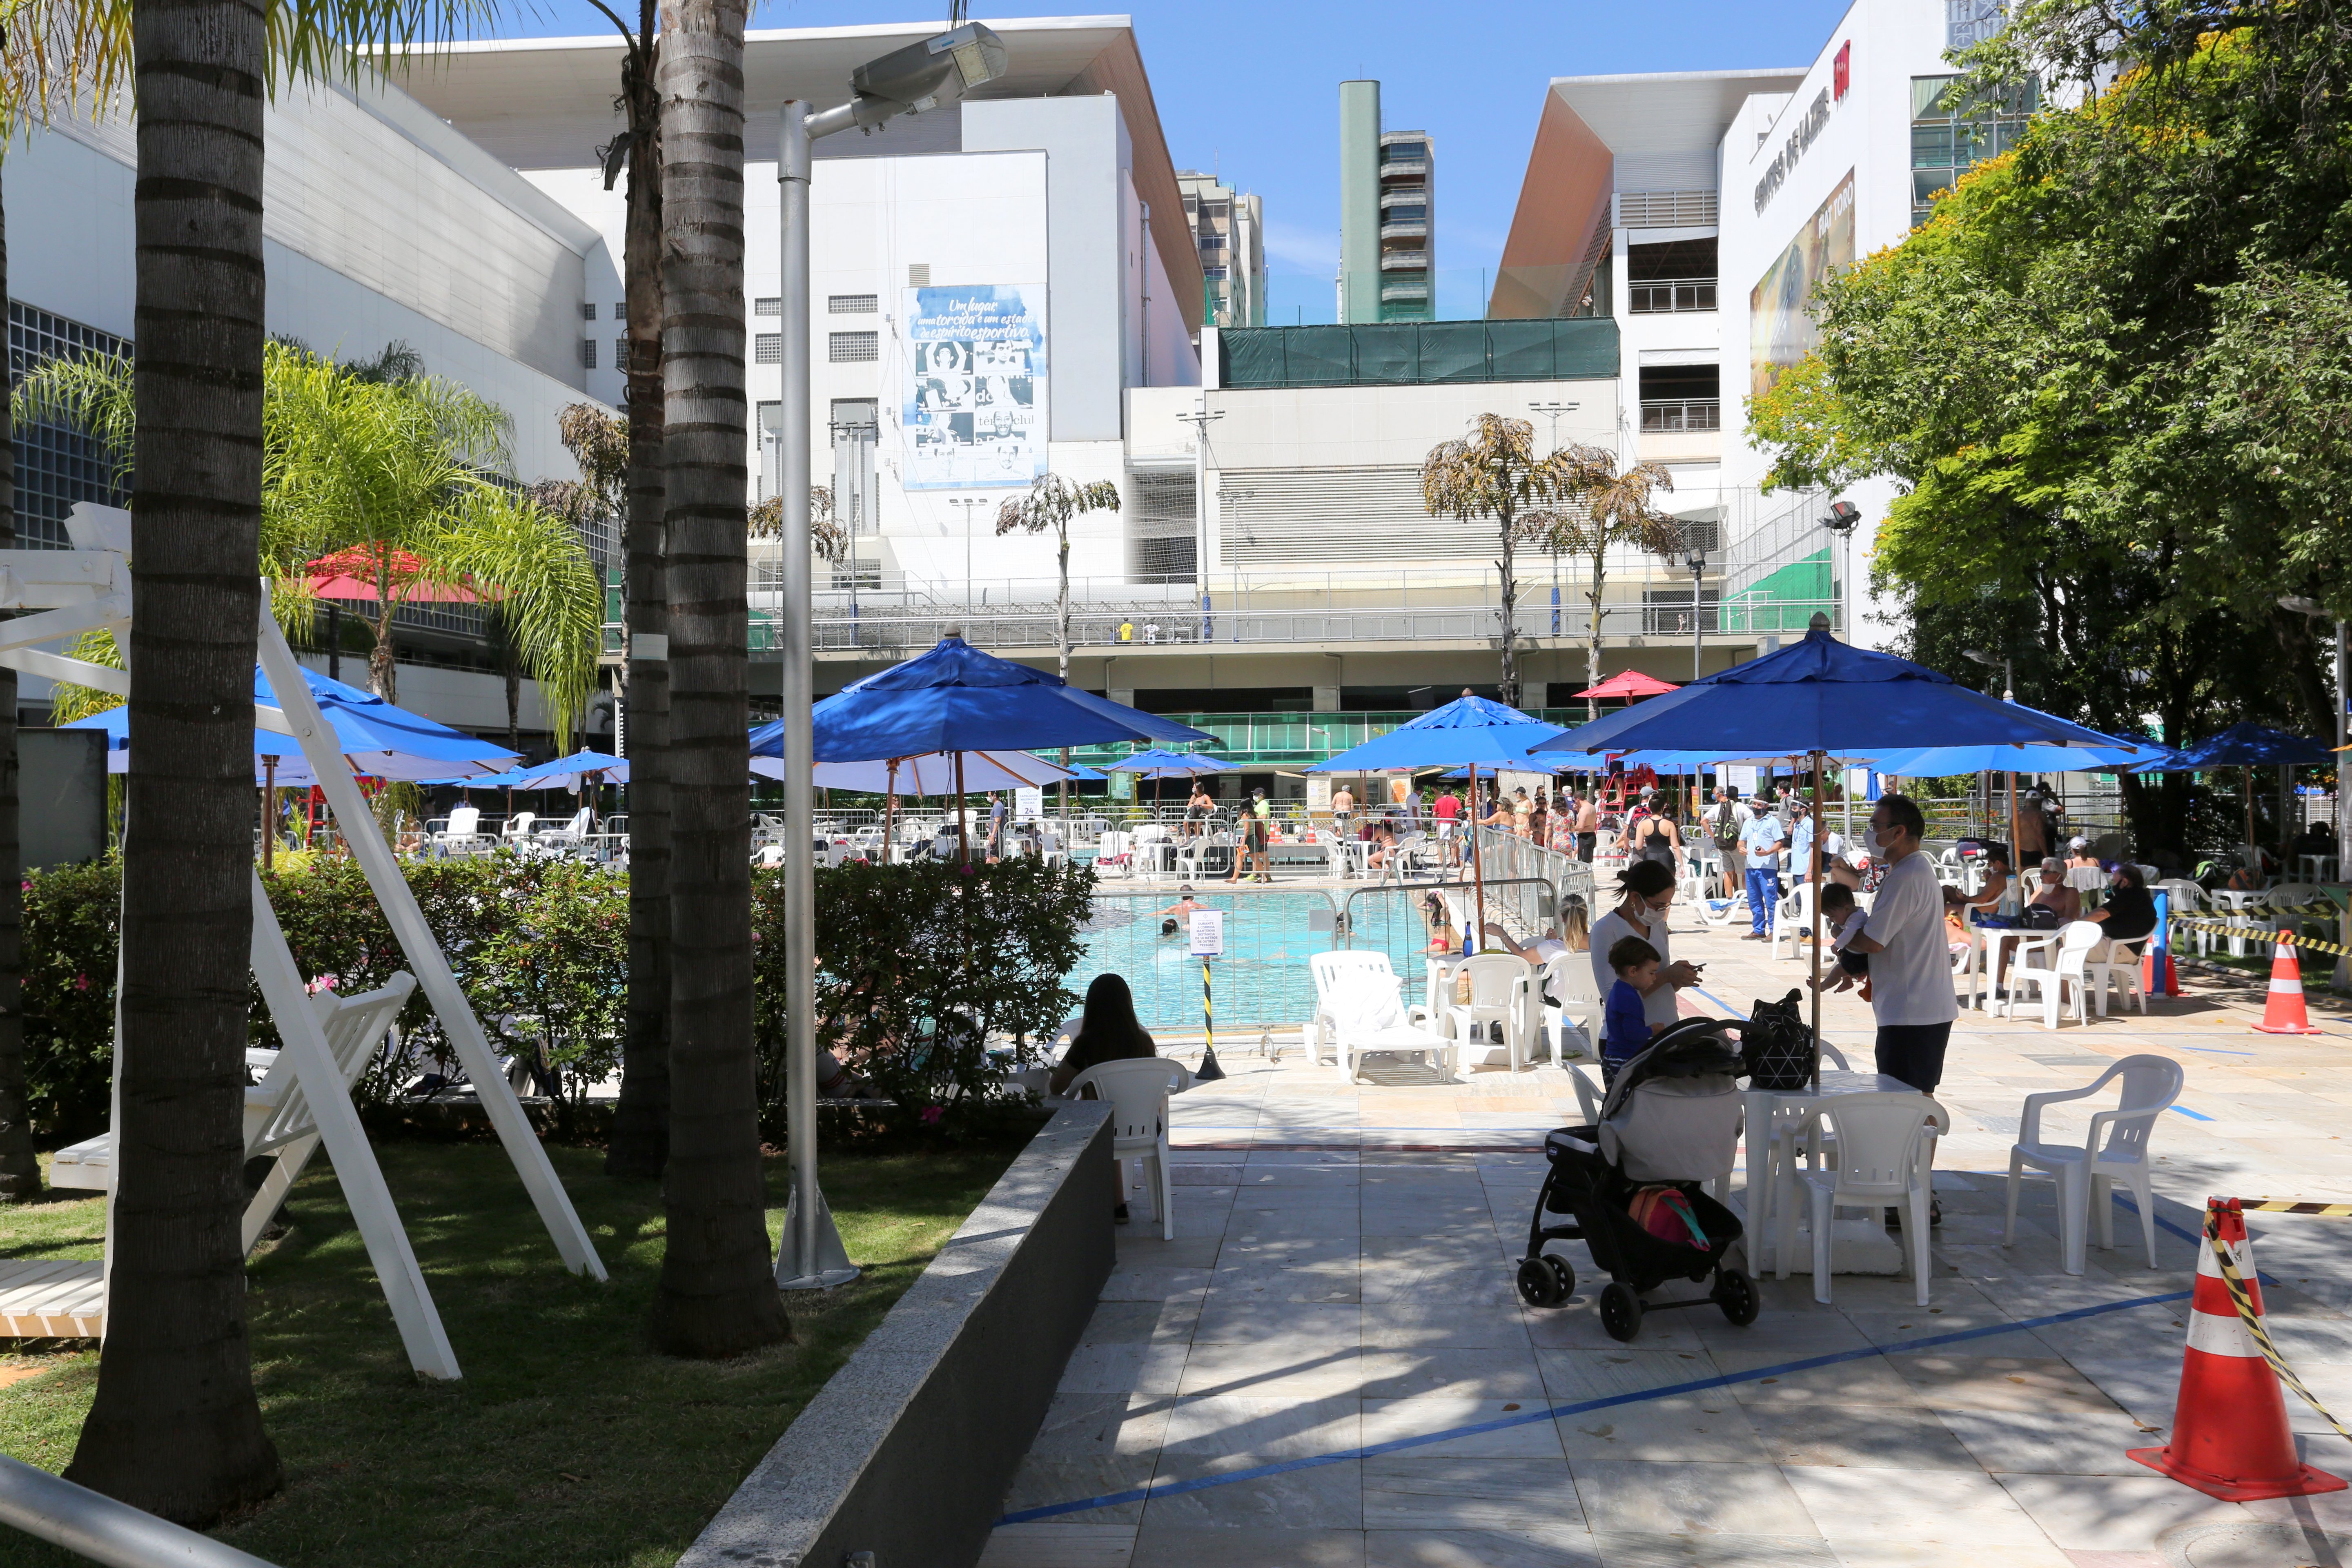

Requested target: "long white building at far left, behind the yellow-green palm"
[{"left": 0, "top": 69, "right": 619, "bottom": 733}]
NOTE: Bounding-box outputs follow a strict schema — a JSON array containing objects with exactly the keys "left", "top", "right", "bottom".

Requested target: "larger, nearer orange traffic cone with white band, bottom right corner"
[{"left": 2126, "top": 1199, "right": 2345, "bottom": 1502}]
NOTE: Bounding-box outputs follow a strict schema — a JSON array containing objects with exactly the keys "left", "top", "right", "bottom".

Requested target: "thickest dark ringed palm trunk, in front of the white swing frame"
[{"left": 66, "top": 0, "right": 280, "bottom": 1523}]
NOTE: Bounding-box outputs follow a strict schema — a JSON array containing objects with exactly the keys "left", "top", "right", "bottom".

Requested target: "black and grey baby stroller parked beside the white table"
[{"left": 1519, "top": 1018, "right": 1759, "bottom": 1340}]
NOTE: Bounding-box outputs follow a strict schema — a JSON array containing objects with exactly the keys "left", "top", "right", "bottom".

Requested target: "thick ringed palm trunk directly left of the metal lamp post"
[{"left": 652, "top": 0, "right": 790, "bottom": 1356}]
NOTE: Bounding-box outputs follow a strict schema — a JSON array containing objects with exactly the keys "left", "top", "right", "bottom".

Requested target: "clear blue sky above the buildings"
[{"left": 491, "top": 0, "right": 1846, "bottom": 322}]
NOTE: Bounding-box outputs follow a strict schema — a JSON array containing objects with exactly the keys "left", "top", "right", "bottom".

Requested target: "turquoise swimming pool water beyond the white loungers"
[{"left": 1068, "top": 889, "right": 1430, "bottom": 1037}]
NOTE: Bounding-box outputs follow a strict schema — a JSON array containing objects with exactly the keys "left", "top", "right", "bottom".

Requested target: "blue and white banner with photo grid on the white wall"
[{"left": 901, "top": 282, "right": 1047, "bottom": 489}]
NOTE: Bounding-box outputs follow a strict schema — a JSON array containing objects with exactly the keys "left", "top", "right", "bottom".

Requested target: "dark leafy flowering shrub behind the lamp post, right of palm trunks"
[{"left": 753, "top": 858, "right": 1094, "bottom": 1138}]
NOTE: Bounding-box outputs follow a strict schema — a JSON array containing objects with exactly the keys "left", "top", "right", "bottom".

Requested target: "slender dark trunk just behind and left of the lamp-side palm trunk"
[{"left": 604, "top": 21, "right": 670, "bottom": 1178}]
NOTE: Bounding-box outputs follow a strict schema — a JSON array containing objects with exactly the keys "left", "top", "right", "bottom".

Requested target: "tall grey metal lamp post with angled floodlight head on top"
[{"left": 776, "top": 21, "right": 1004, "bottom": 1291}]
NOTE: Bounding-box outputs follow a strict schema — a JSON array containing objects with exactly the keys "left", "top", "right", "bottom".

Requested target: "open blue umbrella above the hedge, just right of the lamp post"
[{"left": 750, "top": 633, "right": 1216, "bottom": 858}]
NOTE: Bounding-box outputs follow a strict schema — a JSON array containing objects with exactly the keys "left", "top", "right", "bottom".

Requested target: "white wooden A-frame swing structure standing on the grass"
[{"left": 0, "top": 503, "right": 604, "bottom": 1378}]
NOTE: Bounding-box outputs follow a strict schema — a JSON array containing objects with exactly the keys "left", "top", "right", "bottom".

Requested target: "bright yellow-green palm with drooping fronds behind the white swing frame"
[{"left": 16, "top": 341, "right": 604, "bottom": 736}]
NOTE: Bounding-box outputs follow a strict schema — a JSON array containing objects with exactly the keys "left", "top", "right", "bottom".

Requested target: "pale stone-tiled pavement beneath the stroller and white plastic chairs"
[{"left": 983, "top": 912, "right": 2352, "bottom": 1568}]
